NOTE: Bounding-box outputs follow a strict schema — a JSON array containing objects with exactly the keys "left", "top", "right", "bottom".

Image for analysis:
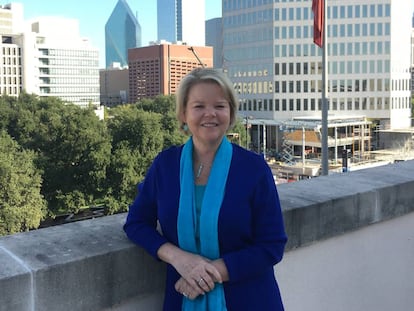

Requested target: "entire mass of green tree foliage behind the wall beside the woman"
[{"left": 0, "top": 93, "right": 245, "bottom": 235}]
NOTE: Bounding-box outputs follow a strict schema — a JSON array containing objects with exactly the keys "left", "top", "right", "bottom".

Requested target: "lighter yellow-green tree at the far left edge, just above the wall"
[{"left": 0, "top": 131, "right": 46, "bottom": 235}]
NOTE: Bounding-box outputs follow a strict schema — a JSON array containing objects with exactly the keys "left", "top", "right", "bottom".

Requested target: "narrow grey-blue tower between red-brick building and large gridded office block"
[{"left": 206, "top": 17, "right": 223, "bottom": 68}]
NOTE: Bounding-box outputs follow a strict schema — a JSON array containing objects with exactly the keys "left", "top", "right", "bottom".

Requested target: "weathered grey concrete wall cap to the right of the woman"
[{"left": 279, "top": 161, "right": 414, "bottom": 250}]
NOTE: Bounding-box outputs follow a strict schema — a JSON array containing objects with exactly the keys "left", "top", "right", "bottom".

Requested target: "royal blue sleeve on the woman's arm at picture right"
[{"left": 222, "top": 164, "right": 287, "bottom": 282}]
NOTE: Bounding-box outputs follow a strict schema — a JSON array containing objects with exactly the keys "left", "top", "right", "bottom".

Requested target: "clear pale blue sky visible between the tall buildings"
[{"left": 14, "top": 0, "right": 223, "bottom": 68}]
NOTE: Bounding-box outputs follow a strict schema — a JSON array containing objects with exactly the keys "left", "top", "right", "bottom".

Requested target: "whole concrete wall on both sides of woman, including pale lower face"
[{"left": 0, "top": 161, "right": 414, "bottom": 311}]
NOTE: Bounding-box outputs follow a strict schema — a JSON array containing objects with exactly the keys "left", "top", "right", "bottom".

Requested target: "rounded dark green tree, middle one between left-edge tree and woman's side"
[{"left": 33, "top": 105, "right": 111, "bottom": 216}]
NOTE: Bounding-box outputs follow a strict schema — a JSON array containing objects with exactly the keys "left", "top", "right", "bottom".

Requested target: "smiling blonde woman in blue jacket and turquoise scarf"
[{"left": 124, "top": 68, "right": 287, "bottom": 311}]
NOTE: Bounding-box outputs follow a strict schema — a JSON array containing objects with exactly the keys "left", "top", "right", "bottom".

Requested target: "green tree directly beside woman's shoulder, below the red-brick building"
[{"left": 106, "top": 105, "right": 164, "bottom": 213}]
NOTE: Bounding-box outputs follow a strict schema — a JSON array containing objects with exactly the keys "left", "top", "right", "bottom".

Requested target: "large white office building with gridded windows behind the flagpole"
[{"left": 223, "top": 0, "right": 412, "bottom": 129}]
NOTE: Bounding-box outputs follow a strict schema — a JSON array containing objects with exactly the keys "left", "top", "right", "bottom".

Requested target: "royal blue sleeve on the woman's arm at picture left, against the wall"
[{"left": 124, "top": 158, "right": 167, "bottom": 259}]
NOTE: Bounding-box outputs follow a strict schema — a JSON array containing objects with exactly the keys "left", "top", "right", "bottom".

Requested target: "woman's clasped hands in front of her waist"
[{"left": 174, "top": 253, "right": 223, "bottom": 299}]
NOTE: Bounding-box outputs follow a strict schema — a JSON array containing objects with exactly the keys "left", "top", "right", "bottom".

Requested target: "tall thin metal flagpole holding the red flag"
[{"left": 321, "top": 0, "right": 329, "bottom": 175}]
